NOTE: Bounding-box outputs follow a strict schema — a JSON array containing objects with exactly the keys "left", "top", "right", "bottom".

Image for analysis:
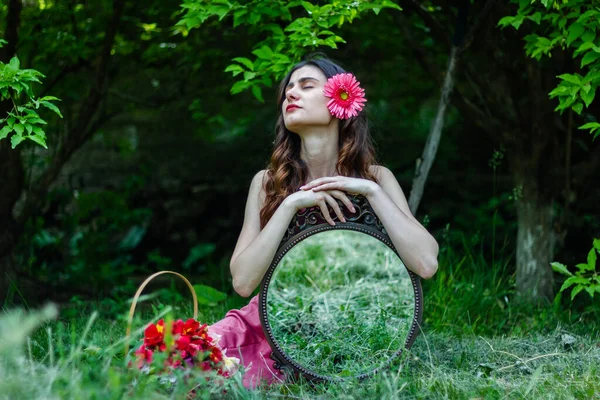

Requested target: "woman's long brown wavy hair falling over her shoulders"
[{"left": 260, "top": 57, "right": 377, "bottom": 229}]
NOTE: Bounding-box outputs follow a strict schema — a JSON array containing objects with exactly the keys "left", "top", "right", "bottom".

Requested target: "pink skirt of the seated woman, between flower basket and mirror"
[{"left": 208, "top": 296, "right": 284, "bottom": 388}]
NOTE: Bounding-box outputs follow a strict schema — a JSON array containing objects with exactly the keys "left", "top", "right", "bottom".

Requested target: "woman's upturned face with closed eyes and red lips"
[{"left": 281, "top": 65, "right": 334, "bottom": 133}]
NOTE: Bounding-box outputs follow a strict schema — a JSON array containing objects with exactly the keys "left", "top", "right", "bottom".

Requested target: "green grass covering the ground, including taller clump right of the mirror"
[{"left": 0, "top": 233, "right": 600, "bottom": 399}]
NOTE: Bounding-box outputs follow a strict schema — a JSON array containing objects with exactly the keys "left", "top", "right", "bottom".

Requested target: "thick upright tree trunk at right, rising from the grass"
[{"left": 515, "top": 166, "right": 556, "bottom": 304}]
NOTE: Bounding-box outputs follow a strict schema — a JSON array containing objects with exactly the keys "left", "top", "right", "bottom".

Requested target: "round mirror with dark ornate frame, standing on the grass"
[{"left": 259, "top": 196, "right": 422, "bottom": 381}]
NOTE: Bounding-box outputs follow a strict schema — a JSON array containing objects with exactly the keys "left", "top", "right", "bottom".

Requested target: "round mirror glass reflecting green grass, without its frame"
[{"left": 267, "top": 230, "right": 414, "bottom": 376}]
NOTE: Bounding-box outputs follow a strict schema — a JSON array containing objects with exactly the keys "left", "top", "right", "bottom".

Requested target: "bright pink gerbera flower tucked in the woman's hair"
[{"left": 324, "top": 73, "right": 367, "bottom": 119}]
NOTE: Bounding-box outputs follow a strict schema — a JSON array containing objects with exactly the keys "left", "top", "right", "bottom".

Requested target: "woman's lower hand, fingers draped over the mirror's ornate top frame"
[{"left": 284, "top": 189, "right": 356, "bottom": 225}]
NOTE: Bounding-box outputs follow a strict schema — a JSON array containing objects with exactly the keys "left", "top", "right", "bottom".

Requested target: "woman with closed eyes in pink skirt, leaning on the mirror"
[{"left": 210, "top": 58, "right": 438, "bottom": 387}]
